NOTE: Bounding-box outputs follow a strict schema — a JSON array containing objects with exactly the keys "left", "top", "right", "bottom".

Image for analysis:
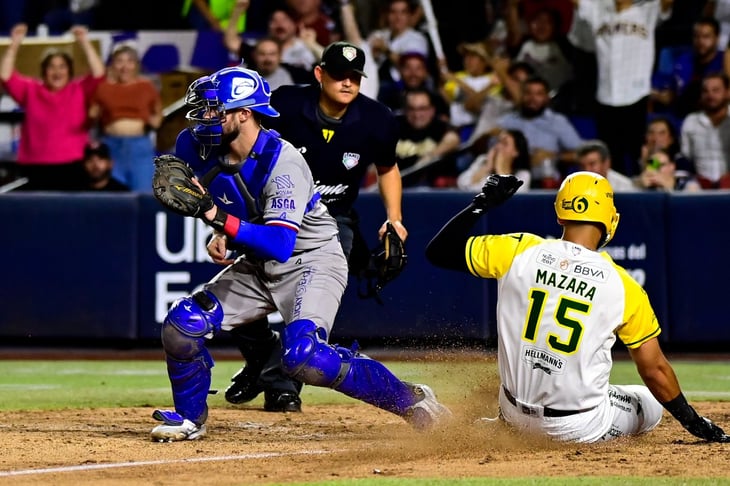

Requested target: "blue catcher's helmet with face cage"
[{"left": 185, "top": 66, "right": 279, "bottom": 158}]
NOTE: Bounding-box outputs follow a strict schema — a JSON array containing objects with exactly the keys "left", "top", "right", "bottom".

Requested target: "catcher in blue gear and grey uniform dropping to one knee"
[{"left": 146, "top": 63, "right": 449, "bottom": 441}]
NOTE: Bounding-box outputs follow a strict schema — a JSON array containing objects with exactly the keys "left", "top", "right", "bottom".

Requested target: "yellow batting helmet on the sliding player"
[{"left": 555, "top": 172, "right": 619, "bottom": 248}]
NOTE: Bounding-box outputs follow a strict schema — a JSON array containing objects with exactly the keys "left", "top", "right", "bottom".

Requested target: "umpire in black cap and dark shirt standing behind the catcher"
[{"left": 225, "top": 42, "right": 408, "bottom": 412}]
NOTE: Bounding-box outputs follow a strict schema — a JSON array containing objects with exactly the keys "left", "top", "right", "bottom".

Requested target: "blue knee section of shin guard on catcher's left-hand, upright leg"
[{"left": 162, "top": 291, "right": 223, "bottom": 359}]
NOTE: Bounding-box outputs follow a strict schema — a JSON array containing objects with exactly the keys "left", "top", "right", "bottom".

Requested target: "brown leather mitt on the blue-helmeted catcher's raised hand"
[{"left": 152, "top": 154, "right": 213, "bottom": 218}]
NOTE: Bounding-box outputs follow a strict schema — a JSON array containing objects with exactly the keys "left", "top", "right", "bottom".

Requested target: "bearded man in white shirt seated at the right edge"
[{"left": 680, "top": 73, "right": 730, "bottom": 189}]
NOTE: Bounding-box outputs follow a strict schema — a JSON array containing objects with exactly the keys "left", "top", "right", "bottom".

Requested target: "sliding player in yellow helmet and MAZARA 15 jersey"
[{"left": 426, "top": 172, "right": 730, "bottom": 442}]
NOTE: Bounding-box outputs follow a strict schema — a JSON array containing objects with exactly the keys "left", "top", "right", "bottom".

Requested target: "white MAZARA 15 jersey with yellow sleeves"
[{"left": 466, "top": 233, "right": 661, "bottom": 410}]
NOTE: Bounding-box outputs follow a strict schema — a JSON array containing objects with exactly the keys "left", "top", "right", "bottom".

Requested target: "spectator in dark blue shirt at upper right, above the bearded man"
[{"left": 651, "top": 17, "right": 725, "bottom": 120}]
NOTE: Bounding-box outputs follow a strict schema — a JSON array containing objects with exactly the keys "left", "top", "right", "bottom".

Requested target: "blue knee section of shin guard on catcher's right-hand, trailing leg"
[{"left": 281, "top": 319, "right": 352, "bottom": 388}]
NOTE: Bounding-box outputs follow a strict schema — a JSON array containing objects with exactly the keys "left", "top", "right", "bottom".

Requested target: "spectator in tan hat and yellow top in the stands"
[{"left": 442, "top": 42, "right": 502, "bottom": 141}]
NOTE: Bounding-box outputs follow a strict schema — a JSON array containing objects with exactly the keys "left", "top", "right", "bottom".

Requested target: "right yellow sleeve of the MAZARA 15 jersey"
[{"left": 617, "top": 270, "right": 661, "bottom": 349}]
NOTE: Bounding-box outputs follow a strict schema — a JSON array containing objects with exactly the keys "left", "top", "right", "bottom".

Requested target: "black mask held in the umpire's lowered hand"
[{"left": 358, "top": 223, "right": 408, "bottom": 304}]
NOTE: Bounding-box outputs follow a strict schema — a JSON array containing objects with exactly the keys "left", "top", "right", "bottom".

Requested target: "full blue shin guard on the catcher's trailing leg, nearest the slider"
[{"left": 282, "top": 320, "right": 420, "bottom": 416}]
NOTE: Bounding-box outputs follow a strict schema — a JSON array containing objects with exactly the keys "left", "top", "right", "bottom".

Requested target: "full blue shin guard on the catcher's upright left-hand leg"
[{"left": 162, "top": 292, "right": 223, "bottom": 424}]
